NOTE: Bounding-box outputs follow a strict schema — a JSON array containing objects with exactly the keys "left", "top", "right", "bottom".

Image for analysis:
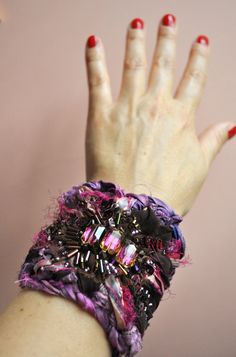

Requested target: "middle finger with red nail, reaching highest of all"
[{"left": 148, "top": 14, "right": 177, "bottom": 96}]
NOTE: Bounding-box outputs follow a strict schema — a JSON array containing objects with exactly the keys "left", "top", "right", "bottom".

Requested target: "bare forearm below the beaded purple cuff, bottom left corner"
[{"left": 0, "top": 289, "right": 111, "bottom": 357}]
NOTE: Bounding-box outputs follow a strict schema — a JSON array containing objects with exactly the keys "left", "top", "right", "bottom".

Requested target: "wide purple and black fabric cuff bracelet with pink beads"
[{"left": 18, "top": 180, "right": 189, "bottom": 356}]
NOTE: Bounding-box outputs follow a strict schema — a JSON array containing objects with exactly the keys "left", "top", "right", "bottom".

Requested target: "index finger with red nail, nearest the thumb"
[{"left": 174, "top": 35, "right": 210, "bottom": 109}]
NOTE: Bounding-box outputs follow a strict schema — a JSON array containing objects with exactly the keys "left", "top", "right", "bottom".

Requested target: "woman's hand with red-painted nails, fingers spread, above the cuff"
[{"left": 85, "top": 14, "right": 235, "bottom": 215}]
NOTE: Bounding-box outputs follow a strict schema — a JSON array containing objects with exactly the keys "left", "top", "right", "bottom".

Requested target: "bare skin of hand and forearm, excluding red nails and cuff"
[{"left": 0, "top": 14, "right": 235, "bottom": 357}]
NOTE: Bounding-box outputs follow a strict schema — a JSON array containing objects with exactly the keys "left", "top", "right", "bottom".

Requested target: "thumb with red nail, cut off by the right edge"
[{"left": 198, "top": 122, "right": 236, "bottom": 164}]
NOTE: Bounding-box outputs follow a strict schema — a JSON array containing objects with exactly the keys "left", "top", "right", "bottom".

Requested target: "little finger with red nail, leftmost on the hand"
[{"left": 85, "top": 36, "right": 112, "bottom": 111}]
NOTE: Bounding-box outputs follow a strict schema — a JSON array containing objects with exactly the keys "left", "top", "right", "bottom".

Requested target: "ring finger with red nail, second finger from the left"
[{"left": 118, "top": 18, "right": 147, "bottom": 103}]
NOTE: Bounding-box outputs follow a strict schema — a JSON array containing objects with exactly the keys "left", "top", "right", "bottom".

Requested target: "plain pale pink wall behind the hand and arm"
[{"left": 0, "top": 0, "right": 236, "bottom": 357}]
